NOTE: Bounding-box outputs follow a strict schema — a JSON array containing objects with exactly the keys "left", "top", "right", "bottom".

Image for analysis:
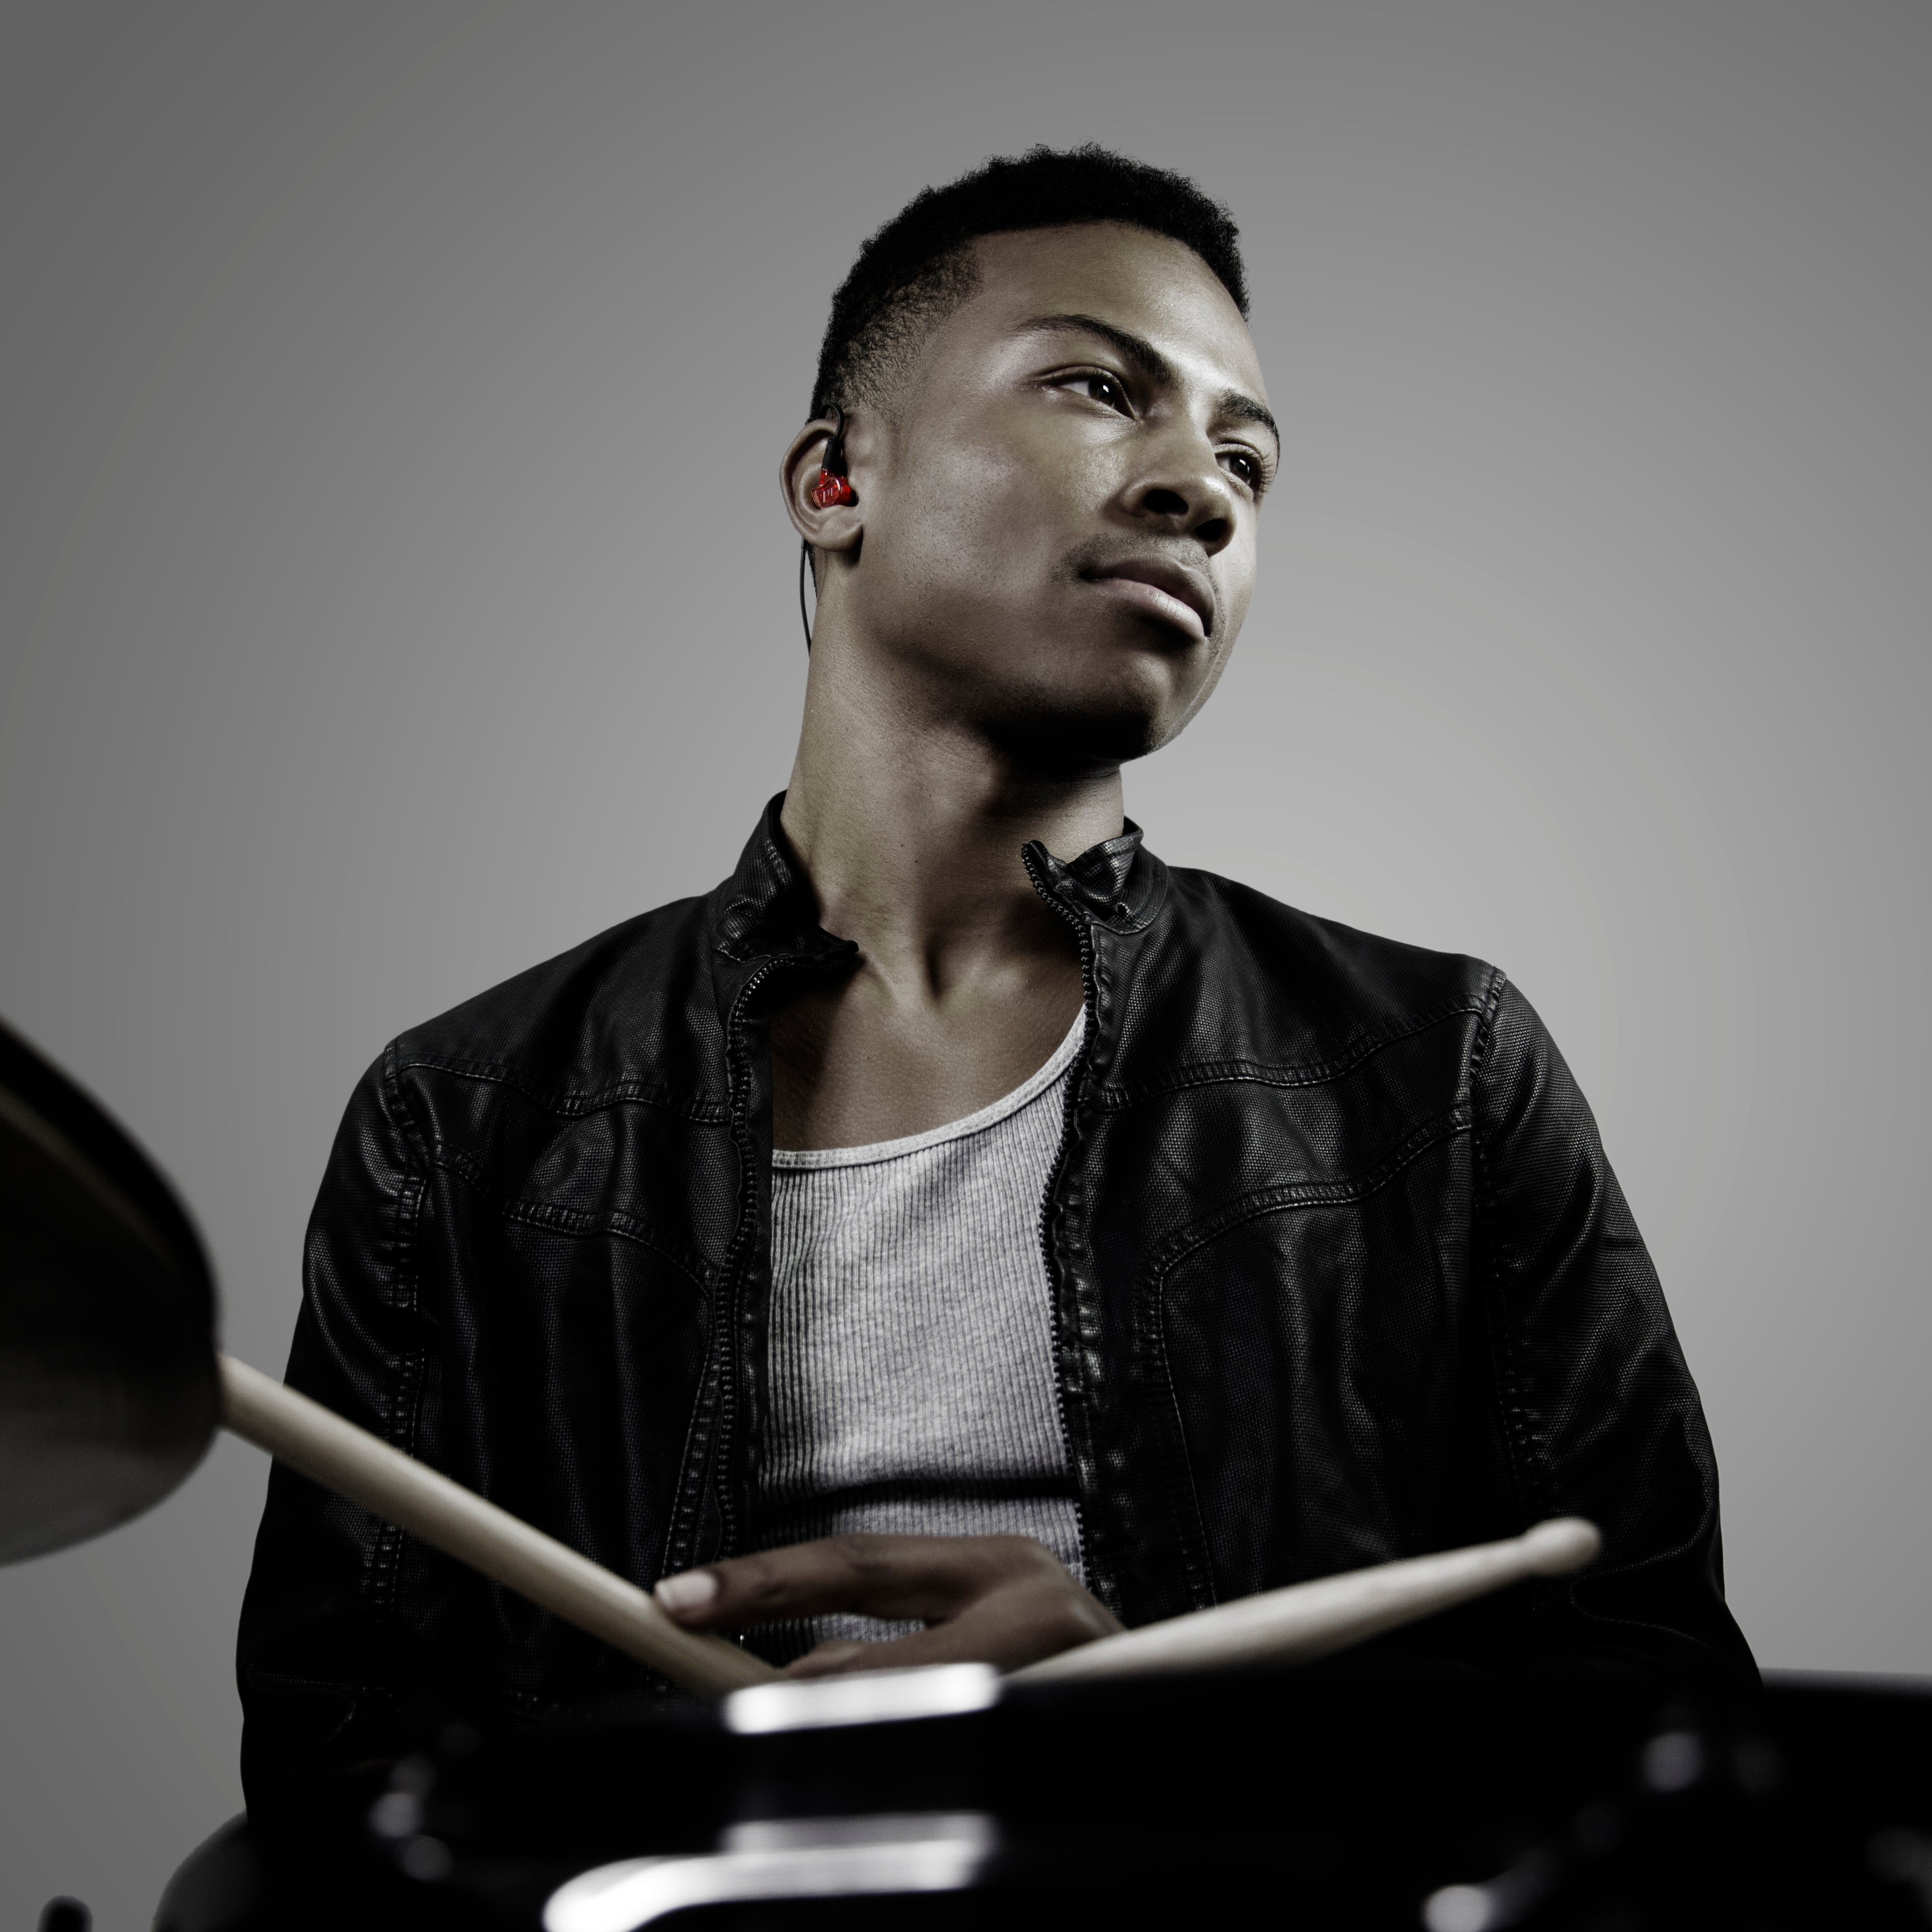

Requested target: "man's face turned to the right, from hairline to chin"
[{"left": 840, "top": 222, "right": 1279, "bottom": 765}]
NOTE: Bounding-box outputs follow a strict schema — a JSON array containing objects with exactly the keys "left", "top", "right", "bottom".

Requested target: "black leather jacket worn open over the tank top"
[{"left": 240, "top": 800, "right": 1750, "bottom": 1801}]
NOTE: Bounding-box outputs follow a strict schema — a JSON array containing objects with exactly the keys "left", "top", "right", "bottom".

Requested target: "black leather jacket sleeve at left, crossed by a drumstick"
[{"left": 236, "top": 1055, "right": 423, "bottom": 1810}]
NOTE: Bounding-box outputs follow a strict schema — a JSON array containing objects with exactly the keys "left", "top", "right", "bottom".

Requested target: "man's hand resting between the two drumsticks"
[{"left": 657, "top": 1536, "right": 1121, "bottom": 1677}]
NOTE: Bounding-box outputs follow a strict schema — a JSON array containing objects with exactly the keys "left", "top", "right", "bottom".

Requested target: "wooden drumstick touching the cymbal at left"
[{"left": 216, "top": 1354, "right": 779, "bottom": 1696}]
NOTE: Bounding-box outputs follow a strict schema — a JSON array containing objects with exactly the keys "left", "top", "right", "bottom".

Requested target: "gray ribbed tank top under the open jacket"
[{"left": 755, "top": 1012, "right": 1086, "bottom": 1640}]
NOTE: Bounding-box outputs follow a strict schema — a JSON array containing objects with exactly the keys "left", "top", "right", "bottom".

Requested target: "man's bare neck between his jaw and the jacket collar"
[{"left": 782, "top": 636, "right": 1122, "bottom": 1003}]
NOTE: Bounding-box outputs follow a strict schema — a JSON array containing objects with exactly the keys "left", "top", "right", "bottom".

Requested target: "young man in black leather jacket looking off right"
[{"left": 242, "top": 149, "right": 1750, "bottom": 1795}]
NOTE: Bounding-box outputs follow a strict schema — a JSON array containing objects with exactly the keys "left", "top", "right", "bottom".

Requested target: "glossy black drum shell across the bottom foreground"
[{"left": 188, "top": 1658, "right": 1932, "bottom": 1932}]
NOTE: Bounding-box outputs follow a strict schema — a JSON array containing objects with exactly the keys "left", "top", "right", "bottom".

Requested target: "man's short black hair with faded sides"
[{"left": 811, "top": 141, "right": 1248, "bottom": 415}]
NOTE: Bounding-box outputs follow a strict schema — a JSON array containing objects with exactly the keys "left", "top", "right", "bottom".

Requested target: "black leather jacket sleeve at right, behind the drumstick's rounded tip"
[{"left": 1470, "top": 981, "right": 1756, "bottom": 1677}]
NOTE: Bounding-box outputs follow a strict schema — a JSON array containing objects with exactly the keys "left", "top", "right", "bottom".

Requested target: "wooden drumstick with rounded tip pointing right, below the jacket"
[{"left": 1012, "top": 1517, "right": 1604, "bottom": 1683}]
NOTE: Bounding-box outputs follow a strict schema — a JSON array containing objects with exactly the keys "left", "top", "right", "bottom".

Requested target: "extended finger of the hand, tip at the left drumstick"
[{"left": 657, "top": 1534, "right": 1066, "bottom": 1631}]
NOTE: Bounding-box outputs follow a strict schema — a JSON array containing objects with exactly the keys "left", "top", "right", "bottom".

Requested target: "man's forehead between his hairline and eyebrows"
[{"left": 939, "top": 222, "right": 1265, "bottom": 400}]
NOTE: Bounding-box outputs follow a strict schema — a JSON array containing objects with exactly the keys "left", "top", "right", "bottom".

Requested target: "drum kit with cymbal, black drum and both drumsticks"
[{"left": 0, "top": 1028, "right": 1932, "bottom": 1932}]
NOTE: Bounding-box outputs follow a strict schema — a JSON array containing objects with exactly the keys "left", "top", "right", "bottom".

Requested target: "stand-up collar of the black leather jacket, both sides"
[{"left": 713, "top": 792, "right": 1167, "bottom": 960}]
